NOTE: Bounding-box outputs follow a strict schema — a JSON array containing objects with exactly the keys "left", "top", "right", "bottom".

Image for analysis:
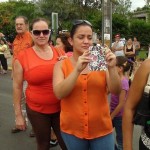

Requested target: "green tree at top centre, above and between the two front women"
[{"left": 38, "top": 0, "right": 99, "bottom": 29}]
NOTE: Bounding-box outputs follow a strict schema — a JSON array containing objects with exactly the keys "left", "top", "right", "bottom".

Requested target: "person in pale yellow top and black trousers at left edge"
[{"left": 0, "top": 38, "right": 8, "bottom": 74}]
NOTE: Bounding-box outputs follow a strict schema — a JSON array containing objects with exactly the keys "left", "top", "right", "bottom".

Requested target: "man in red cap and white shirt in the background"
[{"left": 111, "top": 34, "right": 125, "bottom": 56}]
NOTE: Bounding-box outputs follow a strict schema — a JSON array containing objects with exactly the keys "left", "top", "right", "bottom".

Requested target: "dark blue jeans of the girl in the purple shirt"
[{"left": 112, "top": 117, "right": 123, "bottom": 150}]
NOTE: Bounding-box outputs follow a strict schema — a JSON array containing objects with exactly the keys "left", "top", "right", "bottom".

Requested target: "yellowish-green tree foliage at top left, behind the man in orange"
[{"left": 0, "top": 0, "right": 41, "bottom": 41}]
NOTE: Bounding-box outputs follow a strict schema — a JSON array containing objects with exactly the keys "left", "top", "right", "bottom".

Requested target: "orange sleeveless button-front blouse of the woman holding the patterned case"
[{"left": 60, "top": 58, "right": 113, "bottom": 139}]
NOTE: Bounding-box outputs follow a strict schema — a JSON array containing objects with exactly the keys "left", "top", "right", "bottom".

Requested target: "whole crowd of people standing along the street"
[{"left": 0, "top": 16, "right": 150, "bottom": 150}]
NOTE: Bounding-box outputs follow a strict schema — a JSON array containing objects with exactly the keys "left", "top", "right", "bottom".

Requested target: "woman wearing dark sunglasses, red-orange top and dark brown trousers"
[{"left": 13, "top": 19, "right": 67, "bottom": 150}]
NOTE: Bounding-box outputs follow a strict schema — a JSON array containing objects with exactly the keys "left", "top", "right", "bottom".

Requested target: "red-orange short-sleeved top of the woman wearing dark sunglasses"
[{"left": 16, "top": 47, "right": 63, "bottom": 114}]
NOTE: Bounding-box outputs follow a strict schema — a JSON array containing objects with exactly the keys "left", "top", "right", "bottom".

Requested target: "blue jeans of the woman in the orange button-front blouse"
[{"left": 61, "top": 132, "right": 115, "bottom": 150}]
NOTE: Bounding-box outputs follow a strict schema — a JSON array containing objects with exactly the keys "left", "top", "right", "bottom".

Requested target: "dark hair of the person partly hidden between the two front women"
[{"left": 56, "top": 32, "right": 73, "bottom": 53}]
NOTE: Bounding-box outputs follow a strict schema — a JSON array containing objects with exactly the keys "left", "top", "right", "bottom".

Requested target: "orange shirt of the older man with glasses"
[{"left": 13, "top": 31, "right": 33, "bottom": 57}]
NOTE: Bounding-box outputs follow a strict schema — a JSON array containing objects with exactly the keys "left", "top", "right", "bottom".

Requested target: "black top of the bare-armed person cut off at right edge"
[{"left": 133, "top": 75, "right": 150, "bottom": 126}]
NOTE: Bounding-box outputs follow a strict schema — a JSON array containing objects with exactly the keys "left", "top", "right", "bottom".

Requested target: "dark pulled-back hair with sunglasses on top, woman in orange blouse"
[{"left": 70, "top": 20, "right": 92, "bottom": 38}]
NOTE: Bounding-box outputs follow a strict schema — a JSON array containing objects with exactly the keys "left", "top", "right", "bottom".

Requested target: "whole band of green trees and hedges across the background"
[{"left": 0, "top": 0, "right": 150, "bottom": 46}]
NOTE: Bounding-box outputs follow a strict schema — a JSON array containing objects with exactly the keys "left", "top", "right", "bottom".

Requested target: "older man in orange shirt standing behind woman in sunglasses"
[{"left": 11, "top": 16, "right": 34, "bottom": 137}]
